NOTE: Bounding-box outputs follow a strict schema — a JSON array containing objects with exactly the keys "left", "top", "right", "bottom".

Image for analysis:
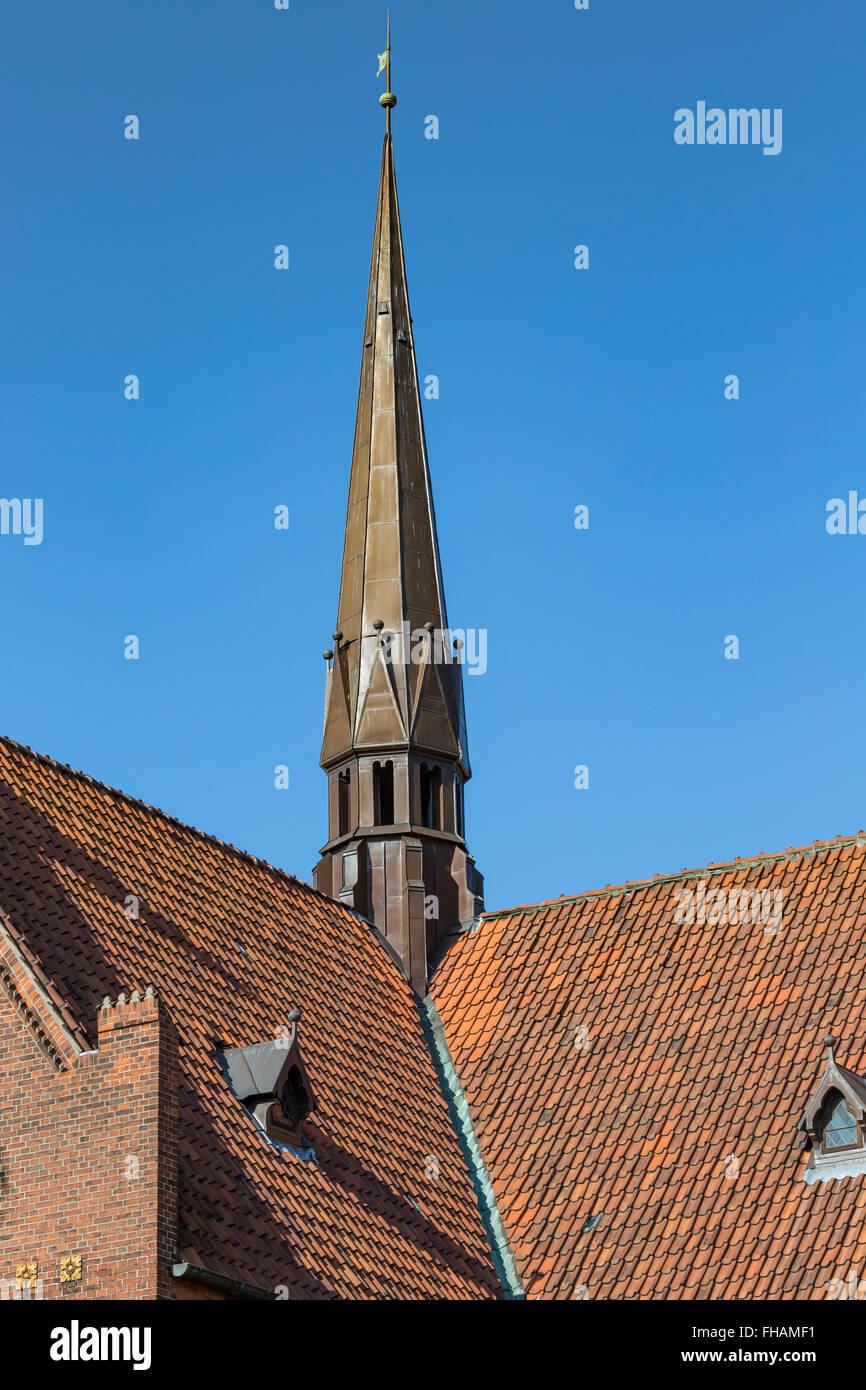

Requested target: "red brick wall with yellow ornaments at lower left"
[{"left": 0, "top": 984, "right": 178, "bottom": 1300}]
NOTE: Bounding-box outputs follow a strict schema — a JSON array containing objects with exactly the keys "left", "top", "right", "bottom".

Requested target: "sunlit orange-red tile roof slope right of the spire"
[{"left": 432, "top": 834, "right": 866, "bottom": 1300}]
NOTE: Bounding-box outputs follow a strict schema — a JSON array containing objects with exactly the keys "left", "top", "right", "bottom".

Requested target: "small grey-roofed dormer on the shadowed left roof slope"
[{"left": 220, "top": 1009, "right": 316, "bottom": 1156}]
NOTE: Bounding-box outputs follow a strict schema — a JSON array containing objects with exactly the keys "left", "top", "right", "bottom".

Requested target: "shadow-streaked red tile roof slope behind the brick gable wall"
[{"left": 0, "top": 739, "right": 499, "bottom": 1298}]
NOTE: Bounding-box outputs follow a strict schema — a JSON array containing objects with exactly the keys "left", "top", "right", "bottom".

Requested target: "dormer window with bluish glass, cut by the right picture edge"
[{"left": 801, "top": 1037, "right": 866, "bottom": 1183}]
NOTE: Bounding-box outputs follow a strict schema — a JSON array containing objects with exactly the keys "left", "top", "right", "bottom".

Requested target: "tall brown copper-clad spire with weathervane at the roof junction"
[{"left": 314, "top": 43, "right": 482, "bottom": 994}]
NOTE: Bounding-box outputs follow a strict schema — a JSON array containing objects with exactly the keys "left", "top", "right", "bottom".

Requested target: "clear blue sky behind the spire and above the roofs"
[{"left": 0, "top": 0, "right": 866, "bottom": 906}]
